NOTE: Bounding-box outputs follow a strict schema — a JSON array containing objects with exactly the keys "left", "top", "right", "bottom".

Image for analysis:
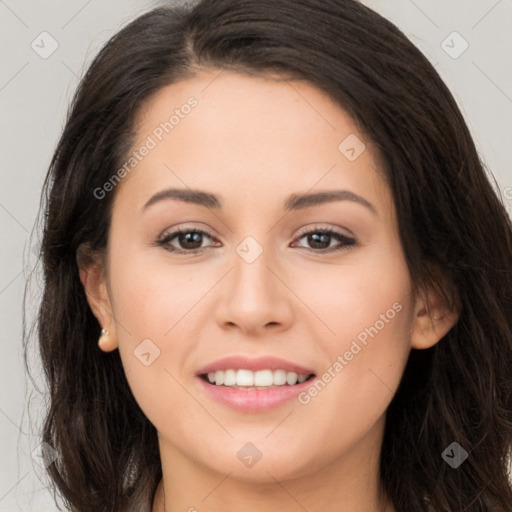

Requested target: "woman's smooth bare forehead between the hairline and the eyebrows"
[{"left": 114, "top": 69, "right": 390, "bottom": 214}]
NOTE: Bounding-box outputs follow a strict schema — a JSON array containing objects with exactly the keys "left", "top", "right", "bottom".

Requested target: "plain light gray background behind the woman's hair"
[{"left": 0, "top": 0, "right": 512, "bottom": 512}]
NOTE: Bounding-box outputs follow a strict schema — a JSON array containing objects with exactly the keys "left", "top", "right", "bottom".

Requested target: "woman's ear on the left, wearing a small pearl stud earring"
[{"left": 76, "top": 244, "right": 118, "bottom": 352}]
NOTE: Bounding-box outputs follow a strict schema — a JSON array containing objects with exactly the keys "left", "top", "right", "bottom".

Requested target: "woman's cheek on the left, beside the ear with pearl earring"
[{"left": 109, "top": 243, "right": 198, "bottom": 408}]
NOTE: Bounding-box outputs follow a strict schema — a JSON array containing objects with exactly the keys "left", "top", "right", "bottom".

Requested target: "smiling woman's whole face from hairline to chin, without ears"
[{"left": 88, "top": 70, "right": 424, "bottom": 481}]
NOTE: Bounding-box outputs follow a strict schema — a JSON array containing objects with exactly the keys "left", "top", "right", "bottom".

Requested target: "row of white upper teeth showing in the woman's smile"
[{"left": 208, "top": 369, "right": 310, "bottom": 388}]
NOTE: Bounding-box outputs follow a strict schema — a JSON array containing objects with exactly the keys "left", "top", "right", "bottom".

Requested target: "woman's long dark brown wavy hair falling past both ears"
[{"left": 25, "top": 0, "right": 512, "bottom": 512}]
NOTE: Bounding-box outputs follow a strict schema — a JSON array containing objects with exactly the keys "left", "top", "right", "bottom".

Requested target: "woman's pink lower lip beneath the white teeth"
[{"left": 198, "top": 377, "right": 315, "bottom": 412}]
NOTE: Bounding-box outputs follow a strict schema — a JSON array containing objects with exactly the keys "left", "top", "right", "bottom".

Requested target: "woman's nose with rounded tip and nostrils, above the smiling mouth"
[{"left": 216, "top": 244, "right": 294, "bottom": 336}]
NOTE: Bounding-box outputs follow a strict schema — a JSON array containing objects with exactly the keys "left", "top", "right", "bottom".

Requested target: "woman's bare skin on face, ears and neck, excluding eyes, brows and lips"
[{"left": 80, "top": 69, "right": 456, "bottom": 512}]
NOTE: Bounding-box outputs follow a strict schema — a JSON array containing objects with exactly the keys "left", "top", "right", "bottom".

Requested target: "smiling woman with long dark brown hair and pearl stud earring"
[{"left": 29, "top": 0, "right": 512, "bottom": 512}]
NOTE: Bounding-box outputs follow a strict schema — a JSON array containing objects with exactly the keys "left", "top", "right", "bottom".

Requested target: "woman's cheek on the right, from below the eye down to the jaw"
[{"left": 290, "top": 242, "right": 413, "bottom": 434}]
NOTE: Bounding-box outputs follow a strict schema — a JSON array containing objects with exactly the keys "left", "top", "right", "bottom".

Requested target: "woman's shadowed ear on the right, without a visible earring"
[{"left": 411, "top": 270, "right": 460, "bottom": 349}]
